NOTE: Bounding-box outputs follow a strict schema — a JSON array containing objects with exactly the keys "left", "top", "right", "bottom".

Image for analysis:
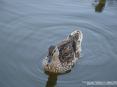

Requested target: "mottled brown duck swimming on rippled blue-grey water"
[{"left": 43, "top": 30, "right": 83, "bottom": 74}]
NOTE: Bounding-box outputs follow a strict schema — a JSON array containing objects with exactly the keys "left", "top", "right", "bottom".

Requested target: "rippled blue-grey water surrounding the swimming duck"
[{"left": 0, "top": 0, "right": 117, "bottom": 87}]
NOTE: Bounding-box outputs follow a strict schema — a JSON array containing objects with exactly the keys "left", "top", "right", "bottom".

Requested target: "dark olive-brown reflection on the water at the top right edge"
[{"left": 95, "top": 0, "right": 106, "bottom": 12}]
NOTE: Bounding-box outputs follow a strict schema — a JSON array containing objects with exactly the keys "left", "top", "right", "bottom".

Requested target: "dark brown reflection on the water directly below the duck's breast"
[{"left": 45, "top": 72, "right": 58, "bottom": 87}]
